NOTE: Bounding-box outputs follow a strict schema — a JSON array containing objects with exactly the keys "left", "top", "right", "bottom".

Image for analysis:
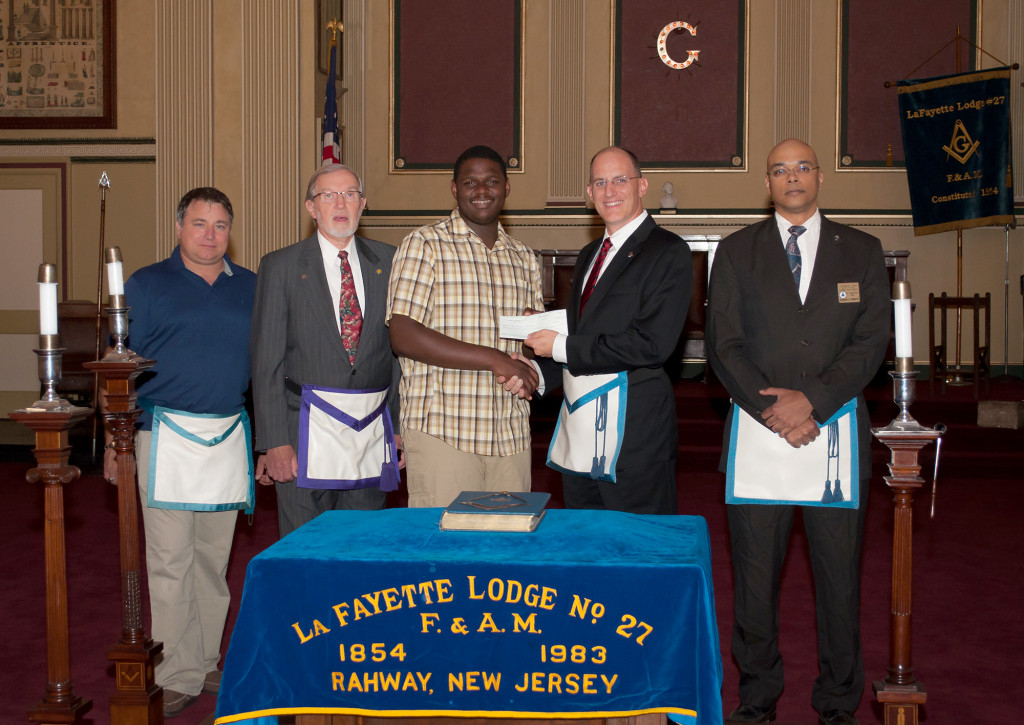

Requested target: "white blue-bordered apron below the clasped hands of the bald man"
[{"left": 725, "top": 398, "right": 860, "bottom": 509}]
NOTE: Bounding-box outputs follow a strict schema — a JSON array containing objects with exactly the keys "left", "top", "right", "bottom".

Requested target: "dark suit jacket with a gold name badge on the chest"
[{"left": 707, "top": 215, "right": 892, "bottom": 477}]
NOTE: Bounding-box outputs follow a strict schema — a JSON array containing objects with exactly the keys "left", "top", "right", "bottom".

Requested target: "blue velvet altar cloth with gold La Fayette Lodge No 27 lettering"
[{"left": 216, "top": 509, "right": 722, "bottom": 724}]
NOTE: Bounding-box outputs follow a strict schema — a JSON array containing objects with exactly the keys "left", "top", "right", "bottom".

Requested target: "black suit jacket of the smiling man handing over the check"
[{"left": 565, "top": 211, "right": 693, "bottom": 471}]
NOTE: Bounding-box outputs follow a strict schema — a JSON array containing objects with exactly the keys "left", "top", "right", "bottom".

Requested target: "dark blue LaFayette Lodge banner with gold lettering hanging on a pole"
[{"left": 897, "top": 68, "right": 1014, "bottom": 236}]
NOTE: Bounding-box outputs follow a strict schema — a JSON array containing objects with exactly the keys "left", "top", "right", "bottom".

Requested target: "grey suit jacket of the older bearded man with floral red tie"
[{"left": 250, "top": 234, "right": 401, "bottom": 451}]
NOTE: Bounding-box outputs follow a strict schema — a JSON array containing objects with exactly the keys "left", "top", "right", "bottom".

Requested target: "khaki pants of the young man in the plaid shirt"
[{"left": 401, "top": 430, "right": 530, "bottom": 509}]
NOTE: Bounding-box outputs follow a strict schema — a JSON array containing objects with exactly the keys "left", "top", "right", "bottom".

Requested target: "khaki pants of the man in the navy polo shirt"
[{"left": 135, "top": 430, "right": 239, "bottom": 694}]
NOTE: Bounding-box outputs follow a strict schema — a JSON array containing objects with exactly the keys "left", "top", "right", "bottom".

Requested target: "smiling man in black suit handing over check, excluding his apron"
[{"left": 526, "top": 146, "right": 693, "bottom": 514}]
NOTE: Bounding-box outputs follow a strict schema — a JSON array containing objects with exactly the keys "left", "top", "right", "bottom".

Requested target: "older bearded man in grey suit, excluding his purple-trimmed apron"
[{"left": 251, "top": 164, "right": 400, "bottom": 537}]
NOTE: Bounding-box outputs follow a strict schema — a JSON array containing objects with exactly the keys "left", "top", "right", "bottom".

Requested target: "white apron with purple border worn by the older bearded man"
[{"left": 297, "top": 378, "right": 398, "bottom": 492}]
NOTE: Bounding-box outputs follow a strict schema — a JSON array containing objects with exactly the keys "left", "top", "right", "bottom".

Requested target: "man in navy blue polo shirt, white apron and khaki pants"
[{"left": 104, "top": 187, "right": 256, "bottom": 717}]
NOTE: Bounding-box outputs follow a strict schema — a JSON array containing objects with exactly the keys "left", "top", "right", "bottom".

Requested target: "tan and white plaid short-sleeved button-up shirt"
[{"left": 387, "top": 210, "right": 544, "bottom": 456}]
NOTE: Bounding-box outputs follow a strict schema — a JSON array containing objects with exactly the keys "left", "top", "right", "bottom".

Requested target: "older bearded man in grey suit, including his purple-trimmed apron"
[{"left": 251, "top": 164, "right": 401, "bottom": 537}]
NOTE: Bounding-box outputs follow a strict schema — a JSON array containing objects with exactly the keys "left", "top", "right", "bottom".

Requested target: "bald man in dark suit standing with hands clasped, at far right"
[{"left": 707, "top": 139, "right": 891, "bottom": 725}]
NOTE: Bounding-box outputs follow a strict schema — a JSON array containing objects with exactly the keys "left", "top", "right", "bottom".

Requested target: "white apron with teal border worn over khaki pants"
[{"left": 141, "top": 403, "right": 255, "bottom": 513}]
